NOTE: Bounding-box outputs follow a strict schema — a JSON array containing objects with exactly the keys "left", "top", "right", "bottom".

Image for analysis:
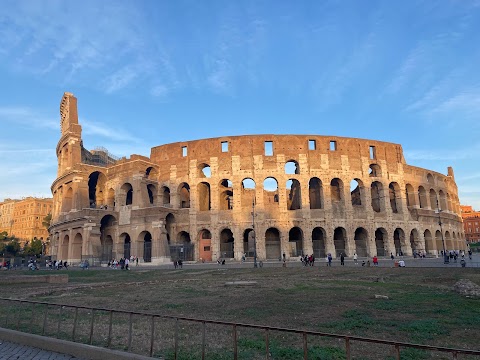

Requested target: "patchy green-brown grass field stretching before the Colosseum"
[{"left": 2, "top": 267, "right": 480, "bottom": 359}]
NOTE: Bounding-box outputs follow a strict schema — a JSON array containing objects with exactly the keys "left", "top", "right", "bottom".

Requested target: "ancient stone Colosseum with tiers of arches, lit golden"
[{"left": 49, "top": 93, "right": 466, "bottom": 264}]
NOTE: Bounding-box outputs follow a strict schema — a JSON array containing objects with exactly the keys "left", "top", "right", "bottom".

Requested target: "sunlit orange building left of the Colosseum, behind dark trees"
[{"left": 0, "top": 197, "right": 53, "bottom": 244}]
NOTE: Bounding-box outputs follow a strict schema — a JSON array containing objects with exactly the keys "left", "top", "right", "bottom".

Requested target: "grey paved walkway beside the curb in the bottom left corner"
[{"left": 0, "top": 340, "right": 86, "bottom": 360}]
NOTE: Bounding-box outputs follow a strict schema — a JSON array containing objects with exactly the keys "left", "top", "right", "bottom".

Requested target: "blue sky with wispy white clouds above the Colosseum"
[{"left": 0, "top": 0, "right": 480, "bottom": 210}]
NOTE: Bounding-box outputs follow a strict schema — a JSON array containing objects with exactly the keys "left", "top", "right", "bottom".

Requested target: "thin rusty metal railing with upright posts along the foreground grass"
[{"left": 0, "top": 298, "right": 480, "bottom": 360}]
